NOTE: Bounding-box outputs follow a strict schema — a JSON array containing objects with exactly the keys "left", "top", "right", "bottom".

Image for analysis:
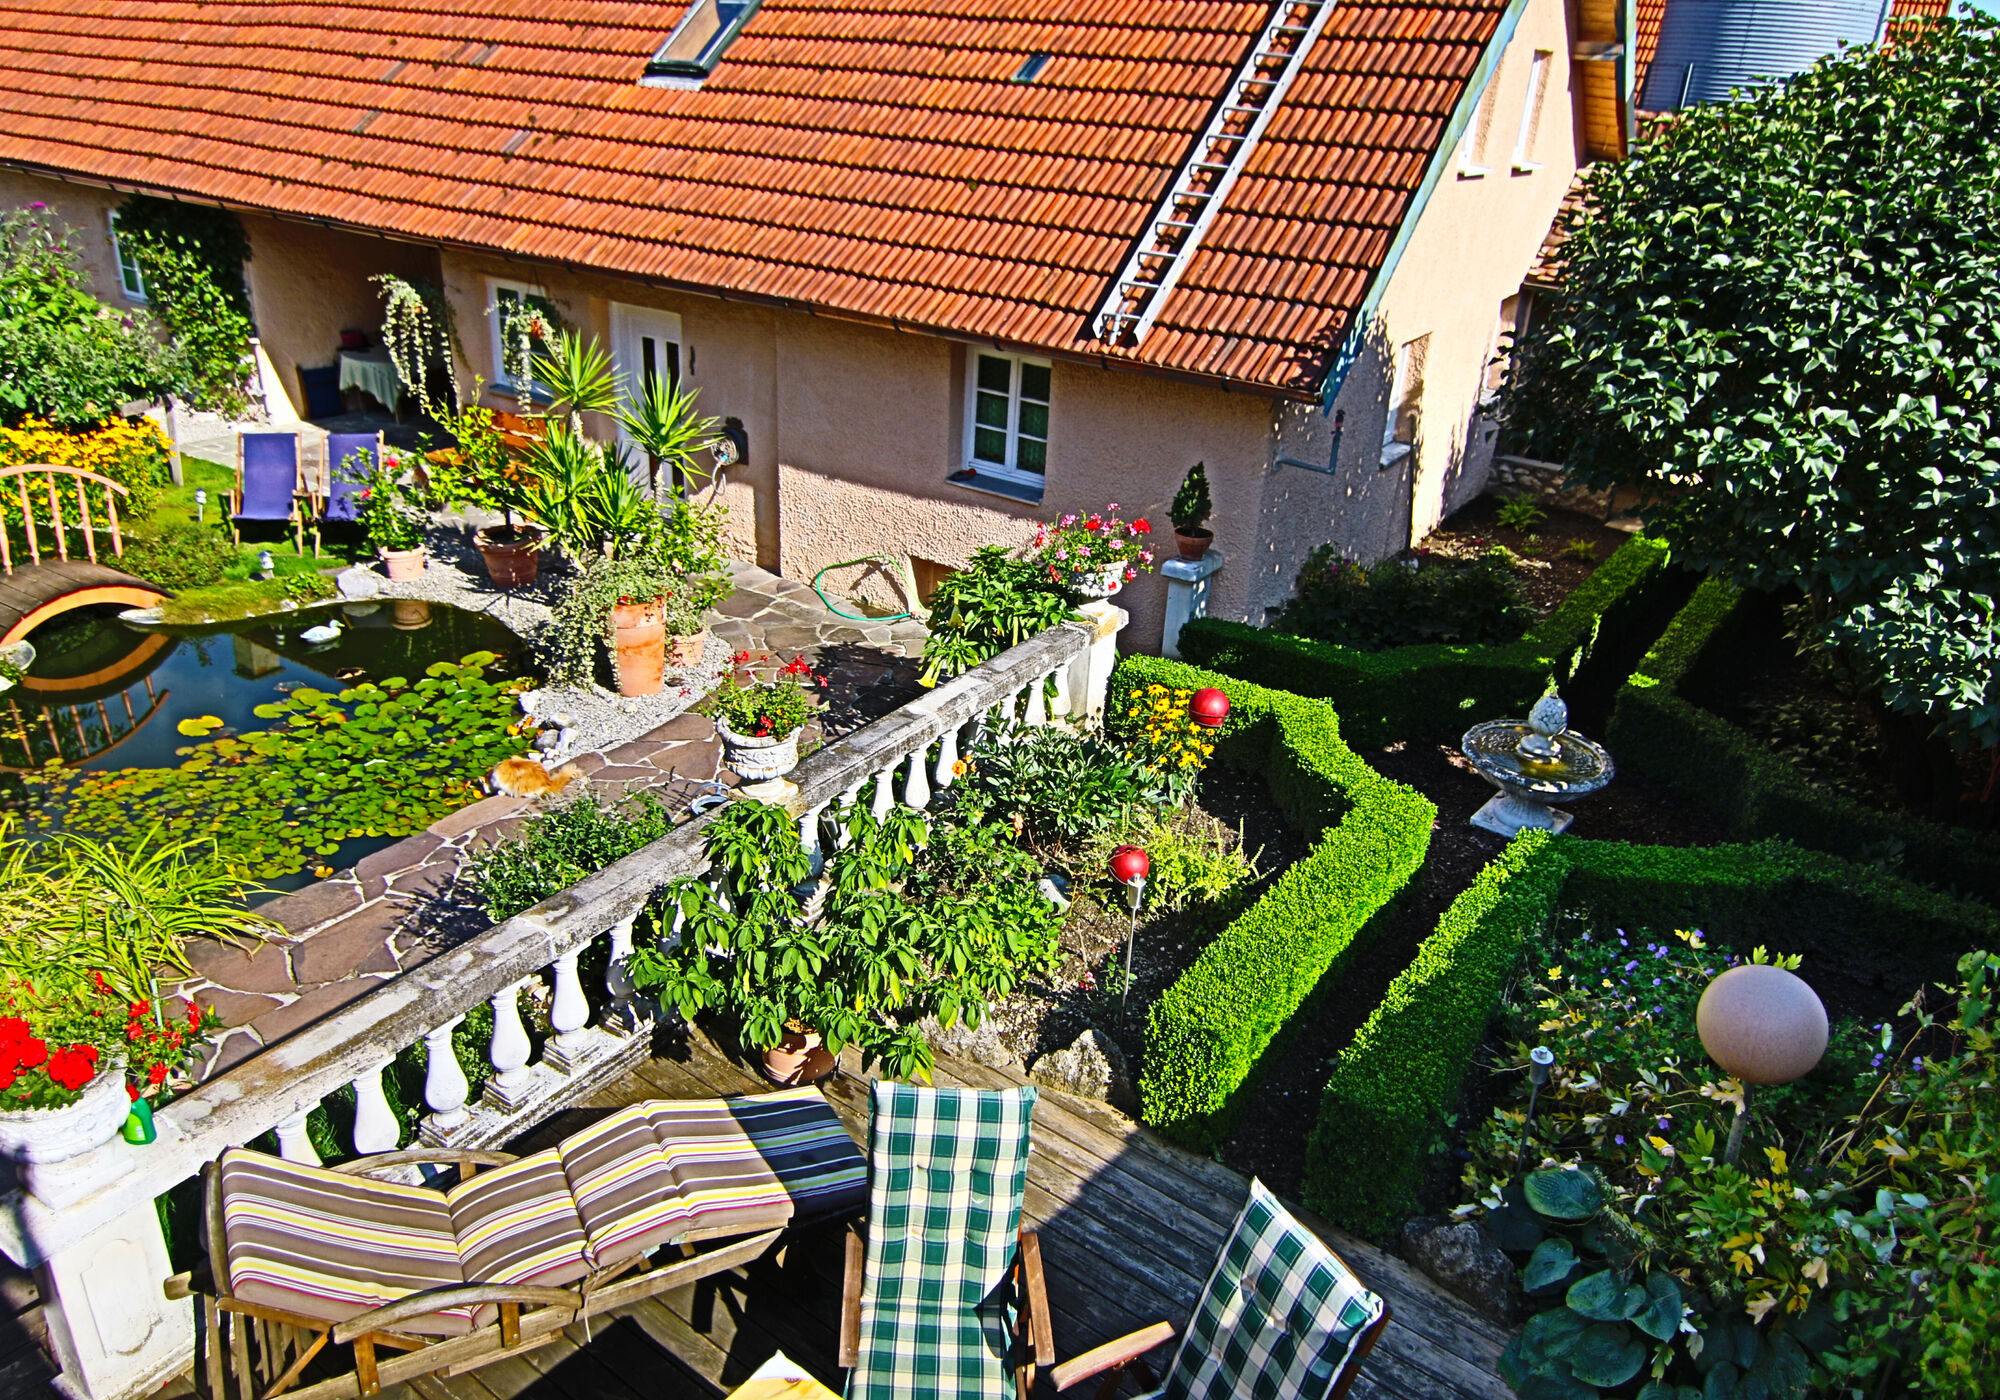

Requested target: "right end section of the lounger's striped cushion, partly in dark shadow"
[{"left": 646, "top": 1088, "right": 868, "bottom": 1234}]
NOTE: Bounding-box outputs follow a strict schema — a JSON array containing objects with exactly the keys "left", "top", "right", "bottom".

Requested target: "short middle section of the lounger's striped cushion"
[{"left": 444, "top": 1148, "right": 590, "bottom": 1286}]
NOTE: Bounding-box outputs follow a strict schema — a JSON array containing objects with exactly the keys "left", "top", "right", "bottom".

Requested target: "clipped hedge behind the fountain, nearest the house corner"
[{"left": 1180, "top": 536, "right": 1666, "bottom": 748}]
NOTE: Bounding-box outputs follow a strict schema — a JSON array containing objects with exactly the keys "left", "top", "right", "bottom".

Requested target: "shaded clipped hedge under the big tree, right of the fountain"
[{"left": 1604, "top": 578, "right": 2000, "bottom": 902}]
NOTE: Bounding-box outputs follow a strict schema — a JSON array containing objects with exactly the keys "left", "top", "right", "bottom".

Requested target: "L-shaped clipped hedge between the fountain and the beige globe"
[{"left": 1304, "top": 832, "right": 1996, "bottom": 1236}]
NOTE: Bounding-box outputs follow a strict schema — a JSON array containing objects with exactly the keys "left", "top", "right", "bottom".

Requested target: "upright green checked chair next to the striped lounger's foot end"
[{"left": 840, "top": 1082, "right": 1056, "bottom": 1400}]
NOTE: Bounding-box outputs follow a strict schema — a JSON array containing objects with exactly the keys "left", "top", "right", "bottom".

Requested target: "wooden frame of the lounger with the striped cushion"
[{"left": 166, "top": 1148, "right": 828, "bottom": 1400}]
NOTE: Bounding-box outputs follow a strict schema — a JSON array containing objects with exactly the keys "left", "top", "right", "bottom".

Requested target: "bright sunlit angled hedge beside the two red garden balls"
[{"left": 1110, "top": 656, "right": 1438, "bottom": 1150}]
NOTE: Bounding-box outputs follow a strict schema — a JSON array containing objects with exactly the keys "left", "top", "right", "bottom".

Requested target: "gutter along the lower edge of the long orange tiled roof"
[{"left": 0, "top": 156, "right": 1318, "bottom": 404}]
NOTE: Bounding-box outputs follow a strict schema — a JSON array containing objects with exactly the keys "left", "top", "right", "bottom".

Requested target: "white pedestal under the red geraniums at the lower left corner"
[{"left": 36, "top": 1198, "right": 194, "bottom": 1400}]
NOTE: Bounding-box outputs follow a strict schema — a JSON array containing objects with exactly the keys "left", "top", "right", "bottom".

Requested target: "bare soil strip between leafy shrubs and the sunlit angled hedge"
[{"left": 994, "top": 768, "right": 1308, "bottom": 1078}]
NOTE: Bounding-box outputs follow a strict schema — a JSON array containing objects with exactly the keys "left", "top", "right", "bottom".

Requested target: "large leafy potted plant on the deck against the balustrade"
[{"left": 632, "top": 802, "right": 1060, "bottom": 1082}]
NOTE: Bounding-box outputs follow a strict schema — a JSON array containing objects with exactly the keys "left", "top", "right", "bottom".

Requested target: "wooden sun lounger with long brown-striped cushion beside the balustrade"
[{"left": 184, "top": 1088, "right": 866, "bottom": 1400}]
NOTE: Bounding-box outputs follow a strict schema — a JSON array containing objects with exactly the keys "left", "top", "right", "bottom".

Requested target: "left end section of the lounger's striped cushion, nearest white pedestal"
[{"left": 220, "top": 1148, "right": 472, "bottom": 1336}]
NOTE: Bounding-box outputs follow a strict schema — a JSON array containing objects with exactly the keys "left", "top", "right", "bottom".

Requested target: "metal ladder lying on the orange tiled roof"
[{"left": 1090, "top": 0, "right": 1334, "bottom": 346}]
